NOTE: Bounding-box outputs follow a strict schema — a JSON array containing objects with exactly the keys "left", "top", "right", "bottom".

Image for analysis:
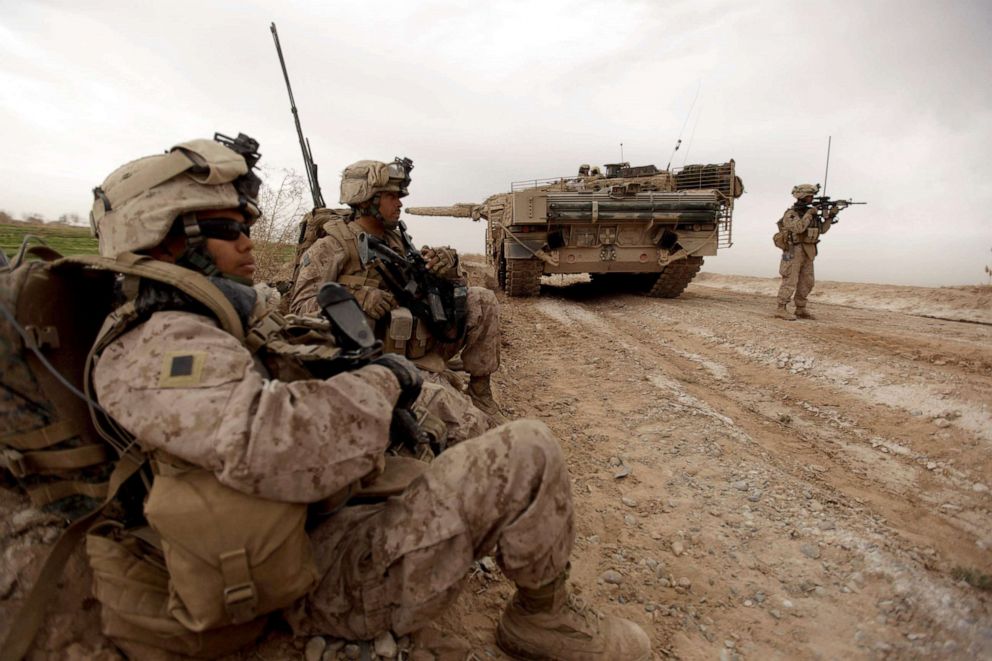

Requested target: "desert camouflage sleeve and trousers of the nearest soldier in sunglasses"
[{"left": 93, "top": 311, "right": 574, "bottom": 639}]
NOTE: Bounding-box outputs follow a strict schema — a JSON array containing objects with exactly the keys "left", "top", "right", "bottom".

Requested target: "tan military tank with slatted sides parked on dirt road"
[{"left": 407, "top": 160, "right": 744, "bottom": 298}]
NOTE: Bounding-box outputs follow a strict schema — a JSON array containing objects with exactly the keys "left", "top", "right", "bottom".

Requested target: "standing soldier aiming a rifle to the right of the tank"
[{"left": 775, "top": 184, "right": 838, "bottom": 321}]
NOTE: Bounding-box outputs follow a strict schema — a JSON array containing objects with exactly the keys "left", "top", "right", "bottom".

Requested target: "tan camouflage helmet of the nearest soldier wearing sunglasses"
[{"left": 90, "top": 134, "right": 261, "bottom": 258}]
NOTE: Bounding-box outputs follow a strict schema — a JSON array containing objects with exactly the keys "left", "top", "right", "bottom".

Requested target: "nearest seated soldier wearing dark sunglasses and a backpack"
[{"left": 87, "top": 135, "right": 651, "bottom": 661}]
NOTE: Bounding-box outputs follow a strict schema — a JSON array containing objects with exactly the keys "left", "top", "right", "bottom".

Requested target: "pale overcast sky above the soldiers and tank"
[{"left": 0, "top": 0, "right": 992, "bottom": 285}]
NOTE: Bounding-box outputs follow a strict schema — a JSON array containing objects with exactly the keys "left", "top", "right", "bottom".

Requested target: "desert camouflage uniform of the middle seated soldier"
[{"left": 290, "top": 220, "right": 499, "bottom": 376}]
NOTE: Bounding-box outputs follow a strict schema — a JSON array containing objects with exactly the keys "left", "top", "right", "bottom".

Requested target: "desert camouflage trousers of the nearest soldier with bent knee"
[{"left": 286, "top": 420, "right": 575, "bottom": 640}]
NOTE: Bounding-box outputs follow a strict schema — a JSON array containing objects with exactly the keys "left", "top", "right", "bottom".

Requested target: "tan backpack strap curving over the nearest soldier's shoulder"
[{"left": 54, "top": 253, "right": 245, "bottom": 342}]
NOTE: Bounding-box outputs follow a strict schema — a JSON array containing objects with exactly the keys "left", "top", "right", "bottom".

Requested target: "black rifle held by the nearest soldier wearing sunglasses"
[{"left": 317, "top": 282, "right": 445, "bottom": 456}]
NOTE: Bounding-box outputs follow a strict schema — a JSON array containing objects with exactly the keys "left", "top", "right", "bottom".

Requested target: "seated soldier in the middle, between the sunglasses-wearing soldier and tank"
[{"left": 290, "top": 159, "right": 506, "bottom": 423}]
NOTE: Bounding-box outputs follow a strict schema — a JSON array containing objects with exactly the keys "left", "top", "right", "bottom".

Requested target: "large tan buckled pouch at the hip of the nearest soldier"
[{"left": 145, "top": 469, "right": 317, "bottom": 631}]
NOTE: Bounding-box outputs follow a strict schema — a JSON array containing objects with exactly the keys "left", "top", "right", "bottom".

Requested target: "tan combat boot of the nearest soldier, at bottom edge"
[{"left": 496, "top": 572, "right": 651, "bottom": 661}]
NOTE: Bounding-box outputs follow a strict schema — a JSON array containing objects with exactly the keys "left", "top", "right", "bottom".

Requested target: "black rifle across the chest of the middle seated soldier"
[{"left": 358, "top": 221, "right": 468, "bottom": 343}]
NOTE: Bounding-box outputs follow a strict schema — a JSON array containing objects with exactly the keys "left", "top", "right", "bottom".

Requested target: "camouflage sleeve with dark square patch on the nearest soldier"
[{"left": 93, "top": 312, "right": 399, "bottom": 502}]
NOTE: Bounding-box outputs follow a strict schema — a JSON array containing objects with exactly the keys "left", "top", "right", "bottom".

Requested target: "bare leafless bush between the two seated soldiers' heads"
[{"left": 251, "top": 170, "right": 308, "bottom": 283}]
